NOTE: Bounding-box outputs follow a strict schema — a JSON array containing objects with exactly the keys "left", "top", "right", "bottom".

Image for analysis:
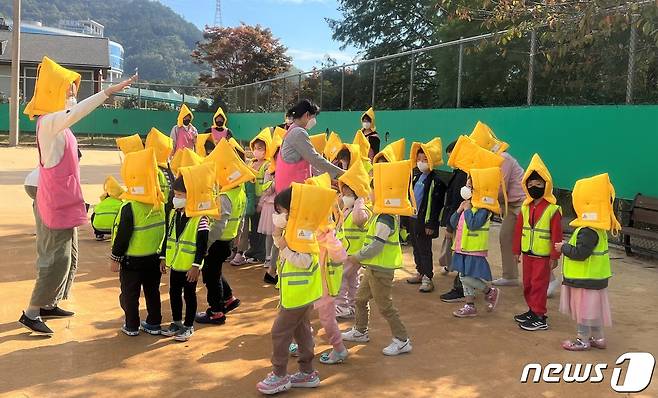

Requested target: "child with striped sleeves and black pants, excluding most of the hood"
[{"left": 160, "top": 175, "right": 210, "bottom": 341}]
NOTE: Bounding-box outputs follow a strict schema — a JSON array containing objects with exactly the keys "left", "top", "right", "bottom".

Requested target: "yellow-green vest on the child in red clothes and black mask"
[{"left": 521, "top": 203, "right": 562, "bottom": 256}]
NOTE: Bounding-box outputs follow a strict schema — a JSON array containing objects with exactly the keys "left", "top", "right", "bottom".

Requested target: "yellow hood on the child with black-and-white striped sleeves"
[{"left": 180, "top": 162, "right": 219, "bottom": 218}]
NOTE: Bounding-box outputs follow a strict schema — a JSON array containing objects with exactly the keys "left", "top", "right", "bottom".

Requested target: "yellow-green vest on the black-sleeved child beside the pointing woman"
[{"left": 112, "top": 200, "right": 165, "bottom": 257}]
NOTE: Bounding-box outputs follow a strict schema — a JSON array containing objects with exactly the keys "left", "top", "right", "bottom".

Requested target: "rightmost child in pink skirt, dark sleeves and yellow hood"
[{"left": 555, "top": 173, "right": 621, "bottom": 351}]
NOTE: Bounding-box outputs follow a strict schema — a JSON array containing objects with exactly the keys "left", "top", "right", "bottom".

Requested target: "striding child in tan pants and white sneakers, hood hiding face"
[{"left": 343, "top": 160, "right": 413, "bottom": 355}]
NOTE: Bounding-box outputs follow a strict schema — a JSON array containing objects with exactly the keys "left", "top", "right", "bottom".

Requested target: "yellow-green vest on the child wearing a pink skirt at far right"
[{"left": 562, "top": 227, "right": 612, "bottom": 280}]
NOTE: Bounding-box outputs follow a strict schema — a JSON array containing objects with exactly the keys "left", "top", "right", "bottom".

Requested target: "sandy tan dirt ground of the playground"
[{"left": 0, "top": 147, "right": 658, "bottom": 398}]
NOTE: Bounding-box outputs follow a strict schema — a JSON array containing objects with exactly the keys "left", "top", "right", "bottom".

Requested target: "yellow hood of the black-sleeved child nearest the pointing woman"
[{"left": 121, "top": 148, "right": 164, "bottom": 207}]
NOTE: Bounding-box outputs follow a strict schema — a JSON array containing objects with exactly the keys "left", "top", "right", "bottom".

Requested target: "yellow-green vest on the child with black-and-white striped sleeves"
[{"left": 166, "top": 210, "right": 201, "bottom": 272}]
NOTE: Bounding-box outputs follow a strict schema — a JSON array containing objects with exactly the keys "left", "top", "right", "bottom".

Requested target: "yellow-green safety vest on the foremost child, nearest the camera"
[{"left": 279, "top": 253, "right": 322, "bottom": 310}]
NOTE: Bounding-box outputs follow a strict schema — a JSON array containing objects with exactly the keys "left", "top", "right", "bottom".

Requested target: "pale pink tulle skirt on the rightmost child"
[{"left": 560, "top": 285, "right": 612, "bottom": 326}]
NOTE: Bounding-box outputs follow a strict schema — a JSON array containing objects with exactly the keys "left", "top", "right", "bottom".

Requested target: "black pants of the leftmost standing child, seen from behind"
[{"left": 119, "top": 255, "right": 162, "bottom": 330}]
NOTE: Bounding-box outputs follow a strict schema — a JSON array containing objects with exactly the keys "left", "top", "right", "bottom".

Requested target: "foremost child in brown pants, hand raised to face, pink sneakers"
[{"left": 256, "top": 183, "right": 336, "bottom": 394}]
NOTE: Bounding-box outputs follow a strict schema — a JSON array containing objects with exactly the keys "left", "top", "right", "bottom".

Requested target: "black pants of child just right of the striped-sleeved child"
[{"left": 201, "top": 240, "right": 233, "bottom": 312}]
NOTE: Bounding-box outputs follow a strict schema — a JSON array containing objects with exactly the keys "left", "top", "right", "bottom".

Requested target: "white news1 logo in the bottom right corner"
[{"left": 520, "top": 352, "right": 656, "bottom": 393}]
